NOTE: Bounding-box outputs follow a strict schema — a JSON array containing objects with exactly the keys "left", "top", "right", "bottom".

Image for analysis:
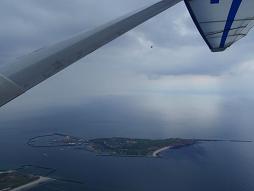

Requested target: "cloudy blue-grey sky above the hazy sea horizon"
[{"left": 0, "top": 0, "right": 254, "bottom": 116}]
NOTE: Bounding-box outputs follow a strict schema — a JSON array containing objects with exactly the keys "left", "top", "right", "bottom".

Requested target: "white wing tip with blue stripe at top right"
[{"left": 185, "top": 0, "right": 254, "bottom": 52}]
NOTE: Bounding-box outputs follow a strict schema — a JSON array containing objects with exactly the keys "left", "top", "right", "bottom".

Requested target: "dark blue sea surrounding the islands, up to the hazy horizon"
[{"left": 0, "top": 95, "right": 254, "bottom": 191}]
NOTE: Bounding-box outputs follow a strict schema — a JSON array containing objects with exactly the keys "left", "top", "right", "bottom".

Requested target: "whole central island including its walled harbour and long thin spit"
[{"left": 27, "top": 133, "right": 252, "bottom": 158}]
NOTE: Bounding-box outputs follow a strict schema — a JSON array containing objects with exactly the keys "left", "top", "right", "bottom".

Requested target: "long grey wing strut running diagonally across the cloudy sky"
[{"left": 0, "top": 0, "right": 182, "bottom": 107}]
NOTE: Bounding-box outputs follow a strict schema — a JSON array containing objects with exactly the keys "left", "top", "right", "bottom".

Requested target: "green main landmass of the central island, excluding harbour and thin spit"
[{"left": 87, "top": 138, "right": 197, "bottom": 157}]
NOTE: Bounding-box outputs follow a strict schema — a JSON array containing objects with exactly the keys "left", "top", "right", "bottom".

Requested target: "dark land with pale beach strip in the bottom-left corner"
[{"left": 0, "top": 171, "right": 51, "bottom": 191}]
